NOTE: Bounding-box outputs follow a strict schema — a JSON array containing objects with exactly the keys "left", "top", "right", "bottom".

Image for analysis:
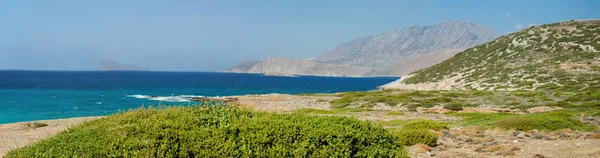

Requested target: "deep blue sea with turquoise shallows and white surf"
[{"left": 0, "top": 71, "right": 397, "bottom": 124}]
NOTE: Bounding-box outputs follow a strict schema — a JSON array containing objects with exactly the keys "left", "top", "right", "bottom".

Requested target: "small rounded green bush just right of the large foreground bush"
[{"left": 395, "top": 129, "right": 438, "bottom": 146}]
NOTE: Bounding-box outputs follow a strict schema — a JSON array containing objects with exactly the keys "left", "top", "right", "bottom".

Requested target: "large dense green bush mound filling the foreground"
[{"left": 7, "top": 106, "right": 406, "bottom": 158}]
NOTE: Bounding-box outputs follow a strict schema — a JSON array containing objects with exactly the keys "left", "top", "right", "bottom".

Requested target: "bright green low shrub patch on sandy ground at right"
[{"left": 449, "top": 110, "right": 596, "bottom": 131}]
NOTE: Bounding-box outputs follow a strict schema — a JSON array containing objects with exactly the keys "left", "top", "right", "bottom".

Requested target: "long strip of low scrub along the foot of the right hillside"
[{"left": 331, "top": 90, "right": 600, "bottom": 111}]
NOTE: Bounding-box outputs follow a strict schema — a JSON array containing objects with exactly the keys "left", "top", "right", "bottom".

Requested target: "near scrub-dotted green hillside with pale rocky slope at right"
[{"left": 382, "top": 20, "right": 600, "bottom": 91}]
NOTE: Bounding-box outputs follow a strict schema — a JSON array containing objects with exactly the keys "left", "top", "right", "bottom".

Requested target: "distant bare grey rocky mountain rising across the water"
[{"left": 226, "top": 21, "right": 499, "bottom": 76}]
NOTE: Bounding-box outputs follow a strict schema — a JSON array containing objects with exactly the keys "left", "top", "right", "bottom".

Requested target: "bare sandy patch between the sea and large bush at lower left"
[{"left": 0, "top": 117, "right": 100, "bottom": 157}]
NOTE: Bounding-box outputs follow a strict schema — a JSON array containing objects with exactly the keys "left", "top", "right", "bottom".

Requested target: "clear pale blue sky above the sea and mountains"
[{"left": 0, "top": 0, "right": 600, "bottom": 71}]
